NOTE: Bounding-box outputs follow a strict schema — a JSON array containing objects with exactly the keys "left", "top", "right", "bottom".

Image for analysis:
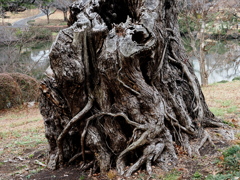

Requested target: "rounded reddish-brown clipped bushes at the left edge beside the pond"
[{"left": 0, "top": 73, "right": 38, "bottom": 109}]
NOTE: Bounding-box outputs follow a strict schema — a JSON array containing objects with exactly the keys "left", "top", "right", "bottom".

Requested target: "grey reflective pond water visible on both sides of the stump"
[{"left": 0, "top": 42, "right": 240, "bottom": 84}]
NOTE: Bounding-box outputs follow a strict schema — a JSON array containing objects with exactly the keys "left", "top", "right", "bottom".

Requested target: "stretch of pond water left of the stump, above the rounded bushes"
[{"left": 0, "top": 42, "right": 52, "bottom": 79}]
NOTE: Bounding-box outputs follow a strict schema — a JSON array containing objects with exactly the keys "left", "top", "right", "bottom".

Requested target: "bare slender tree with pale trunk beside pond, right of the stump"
[{"left": 179, "top": 0, "right": 238, "bottom": 86}]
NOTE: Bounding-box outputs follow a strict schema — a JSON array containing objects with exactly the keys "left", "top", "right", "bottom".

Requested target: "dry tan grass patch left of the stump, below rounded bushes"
[{"left": 0, "top": 107, "right": 47, "bottom": 179}]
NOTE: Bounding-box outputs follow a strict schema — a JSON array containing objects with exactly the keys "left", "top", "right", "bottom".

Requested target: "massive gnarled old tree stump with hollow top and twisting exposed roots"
[{"left": 40, "top": 0, "right": 222, "bottom": 176}]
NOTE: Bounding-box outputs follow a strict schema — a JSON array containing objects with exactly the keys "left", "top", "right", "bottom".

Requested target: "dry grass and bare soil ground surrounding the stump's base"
[{"left": 0, "top": 81, "right": 240, "bottom": 180}]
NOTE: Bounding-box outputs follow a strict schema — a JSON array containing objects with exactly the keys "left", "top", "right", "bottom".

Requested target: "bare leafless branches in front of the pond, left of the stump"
[{"left": 0, "top": 26, "right": 52, "bottom": 79}]
